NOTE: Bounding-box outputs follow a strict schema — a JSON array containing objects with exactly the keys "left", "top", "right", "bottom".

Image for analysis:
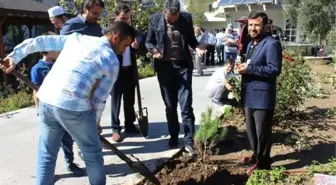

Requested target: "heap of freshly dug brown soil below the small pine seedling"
[{"left": 141, "top": 155, "right": 248, "bottom": 185}]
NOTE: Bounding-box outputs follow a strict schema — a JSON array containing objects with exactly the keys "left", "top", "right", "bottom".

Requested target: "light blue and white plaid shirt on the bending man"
[{"left": 9, "top": 33, "right": 119, "bottom": 120}]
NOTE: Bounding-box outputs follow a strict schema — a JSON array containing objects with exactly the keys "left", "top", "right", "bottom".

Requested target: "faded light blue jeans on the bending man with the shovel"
[{"left": 36, "top": 102, "right": 106, "bottom": 185}]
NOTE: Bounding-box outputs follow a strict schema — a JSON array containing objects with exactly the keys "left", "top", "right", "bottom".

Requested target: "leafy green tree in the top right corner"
[{"left": 286, "top": 0, "right": 336, "bottom": 43}]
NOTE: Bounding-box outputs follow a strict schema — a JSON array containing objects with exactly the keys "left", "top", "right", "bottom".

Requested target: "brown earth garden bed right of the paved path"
[{"left": 141, "top": 59, "right": 336, "bottom": 185}]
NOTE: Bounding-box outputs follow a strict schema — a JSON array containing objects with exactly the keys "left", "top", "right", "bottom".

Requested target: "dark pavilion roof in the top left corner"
[{"left": 0, "top": 0, "right": 50, "bottom": 18}]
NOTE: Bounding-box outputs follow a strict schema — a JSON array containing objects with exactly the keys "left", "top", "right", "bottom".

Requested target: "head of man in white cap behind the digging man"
[{"left": 48, "top": 6, "right": 68, "bottom": 29}]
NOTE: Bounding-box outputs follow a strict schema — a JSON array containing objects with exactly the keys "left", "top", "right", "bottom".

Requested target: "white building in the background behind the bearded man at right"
[{"left": 202, "top": 0, "right": 309, "bottom": 50}]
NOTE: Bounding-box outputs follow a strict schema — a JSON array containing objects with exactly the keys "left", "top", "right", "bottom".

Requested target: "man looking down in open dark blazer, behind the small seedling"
[{"left": 146, "top": 0, "right": 206, "bottom": 155}]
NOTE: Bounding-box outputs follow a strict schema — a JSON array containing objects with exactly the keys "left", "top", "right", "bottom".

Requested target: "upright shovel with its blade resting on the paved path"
[{"left": 136, "top": 65, "right": 148, "bottom": 138}]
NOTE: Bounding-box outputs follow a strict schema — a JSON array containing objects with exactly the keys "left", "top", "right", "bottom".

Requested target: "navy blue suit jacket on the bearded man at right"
[{"left": 241, "top": 36, "right": 282, "bottom": 110}]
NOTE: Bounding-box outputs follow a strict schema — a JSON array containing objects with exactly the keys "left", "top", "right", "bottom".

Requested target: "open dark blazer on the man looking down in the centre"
[{"left": 145, "top": 12, "right": 199, "bottom": 69}]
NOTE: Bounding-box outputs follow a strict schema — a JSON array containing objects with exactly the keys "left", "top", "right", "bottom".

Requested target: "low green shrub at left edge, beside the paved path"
[{"left": 0, "top": 91, "right": 34, "bottom": 113}]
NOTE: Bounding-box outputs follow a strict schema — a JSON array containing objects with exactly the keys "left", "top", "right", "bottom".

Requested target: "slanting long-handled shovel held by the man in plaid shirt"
[{"left": 0, "top": 59, "right": 160, "bottom": 185}]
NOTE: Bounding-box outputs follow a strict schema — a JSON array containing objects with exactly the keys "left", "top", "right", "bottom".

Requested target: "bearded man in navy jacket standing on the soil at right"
[{"left": 237, "top": 12, "right": 282, "bottom": 175}]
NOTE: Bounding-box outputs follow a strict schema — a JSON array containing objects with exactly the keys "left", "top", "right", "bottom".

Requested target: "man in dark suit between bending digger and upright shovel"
[{"left": 111, "top": 3, "right": 144, "bottom": 142}]
